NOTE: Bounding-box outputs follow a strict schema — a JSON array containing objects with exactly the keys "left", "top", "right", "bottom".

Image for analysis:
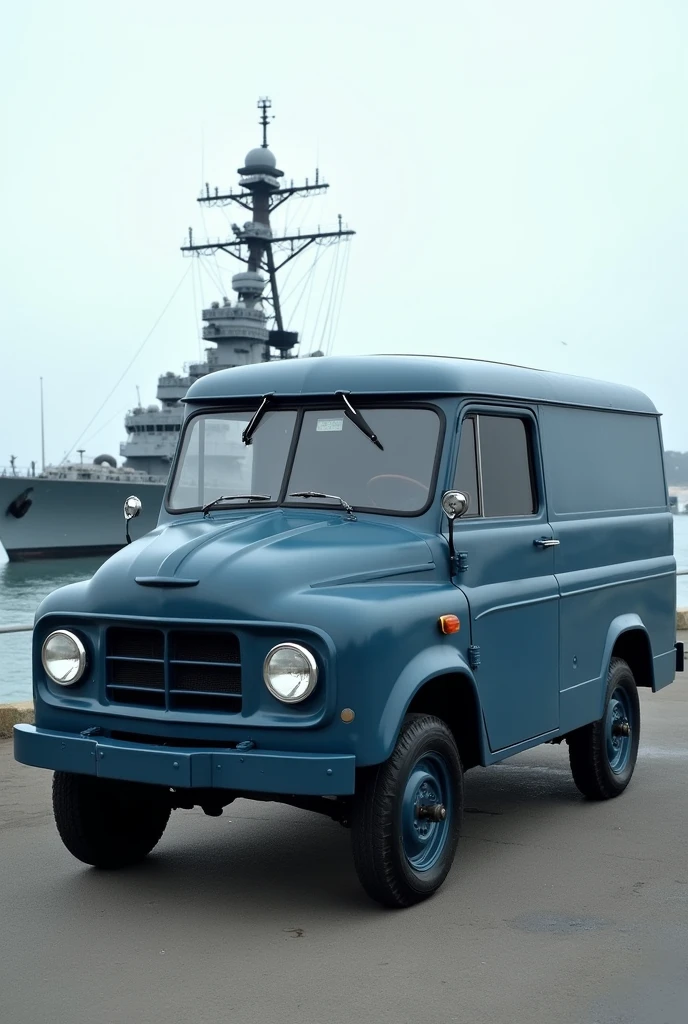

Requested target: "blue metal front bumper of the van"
[{"left": 14, "top": 725, "right": 356, "bottom": 797}]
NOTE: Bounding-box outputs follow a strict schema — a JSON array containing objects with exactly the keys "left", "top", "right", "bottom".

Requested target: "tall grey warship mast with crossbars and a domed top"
[{"left": 181, "top": 97, "right": 354, "bottom": 359}]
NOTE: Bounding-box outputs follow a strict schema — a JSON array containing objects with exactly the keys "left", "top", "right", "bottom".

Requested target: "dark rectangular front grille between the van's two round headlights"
[{"left": 105, "top": 626, "right": 242, "bottom": 712}]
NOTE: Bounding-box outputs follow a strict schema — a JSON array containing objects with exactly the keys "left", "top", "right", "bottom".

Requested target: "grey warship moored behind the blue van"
[{"left": 0, "top": 97, "right": 354, "bottom": 561}]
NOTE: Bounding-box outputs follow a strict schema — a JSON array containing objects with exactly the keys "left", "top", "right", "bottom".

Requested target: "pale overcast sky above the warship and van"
[{"left": 0, "top": 0, "right": 688, "bottom": 465}]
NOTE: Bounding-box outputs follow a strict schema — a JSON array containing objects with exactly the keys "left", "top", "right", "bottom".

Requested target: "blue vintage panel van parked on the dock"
[{"left": 14, "top": 356, "right": 682, "bottom": 906}]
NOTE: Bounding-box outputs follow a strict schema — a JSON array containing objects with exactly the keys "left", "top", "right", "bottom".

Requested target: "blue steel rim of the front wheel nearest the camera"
[{"left": 401, "top": 752, "right": 453, "bottom": 871}]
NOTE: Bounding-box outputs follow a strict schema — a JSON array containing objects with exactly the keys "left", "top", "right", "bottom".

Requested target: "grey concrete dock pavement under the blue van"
[{"left": 0, "top": 647, "right": 688, "bottom": 1024}]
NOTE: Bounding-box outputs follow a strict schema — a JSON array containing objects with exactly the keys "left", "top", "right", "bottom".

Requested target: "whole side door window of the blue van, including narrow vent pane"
[{"left": 454, "top": 414, "right": 538, "bottom": 518}]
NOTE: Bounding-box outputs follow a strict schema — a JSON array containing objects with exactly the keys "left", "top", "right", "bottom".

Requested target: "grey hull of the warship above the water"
[{"left": 0, "top": 476, "right": 165, "bottom": 562}]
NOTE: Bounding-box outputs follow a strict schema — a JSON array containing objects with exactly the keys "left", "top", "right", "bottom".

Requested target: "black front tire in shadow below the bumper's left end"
[{"left": 52, "top": 771, "right": 171, "bottom": 868}]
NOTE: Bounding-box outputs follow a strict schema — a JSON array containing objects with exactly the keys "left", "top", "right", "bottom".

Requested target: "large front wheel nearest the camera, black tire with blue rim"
[{"left": 351, "top": 715, "right": 464, "bottom": 907}]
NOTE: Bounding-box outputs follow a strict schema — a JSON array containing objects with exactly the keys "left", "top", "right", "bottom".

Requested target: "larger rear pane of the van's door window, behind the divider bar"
[{"left": 478, "top": 416, "right": 538, "bottom": 516}]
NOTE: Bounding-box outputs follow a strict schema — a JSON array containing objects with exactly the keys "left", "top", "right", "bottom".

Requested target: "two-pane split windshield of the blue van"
[{"left": 168, "top": 406, "right": 440, "bottom": 513}]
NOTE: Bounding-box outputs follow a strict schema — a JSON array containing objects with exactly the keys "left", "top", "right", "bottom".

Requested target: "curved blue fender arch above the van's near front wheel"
[{"left": 375, "top": 644, "right": 486, "bottom": 761}]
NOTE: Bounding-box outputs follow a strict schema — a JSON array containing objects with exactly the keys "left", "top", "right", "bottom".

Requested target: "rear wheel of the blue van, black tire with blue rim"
[{"left": 567, "top": 657, "right": 640, "bottom": 800}]
